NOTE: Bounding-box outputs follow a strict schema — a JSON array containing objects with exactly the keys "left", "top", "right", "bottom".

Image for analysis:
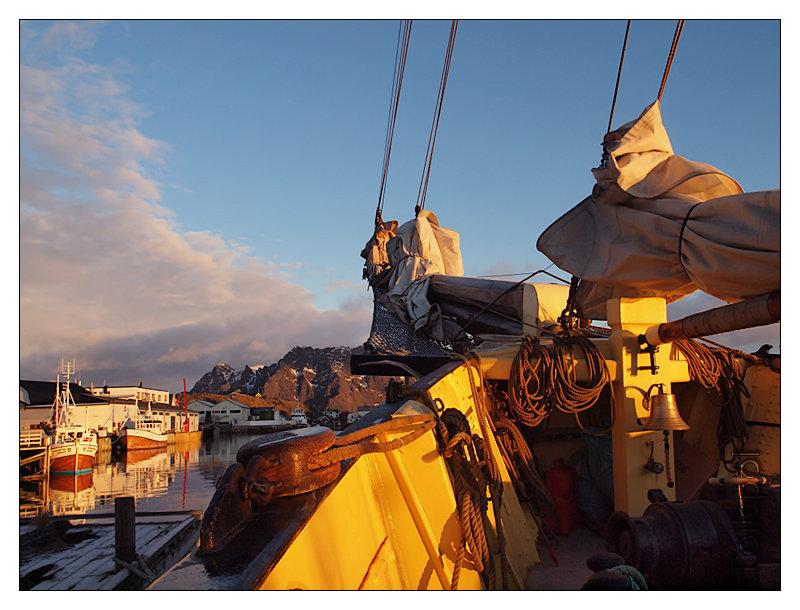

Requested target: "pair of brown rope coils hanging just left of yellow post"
[{"left": 508, "top": 335, "right": 610, "bottom": 428}]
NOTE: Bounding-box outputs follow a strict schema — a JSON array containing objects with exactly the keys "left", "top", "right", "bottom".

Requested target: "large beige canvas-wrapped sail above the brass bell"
[{"left": 536, "top": 102, "right": 780, "bottom": 319}]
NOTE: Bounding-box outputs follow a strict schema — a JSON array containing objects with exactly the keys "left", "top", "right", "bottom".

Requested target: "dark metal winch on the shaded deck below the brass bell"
[{"left": 606, "top": 477, "right": 780, "bottom": 589}]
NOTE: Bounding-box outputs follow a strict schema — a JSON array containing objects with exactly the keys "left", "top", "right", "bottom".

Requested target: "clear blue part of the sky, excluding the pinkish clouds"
[{"left": 22, "top": 20, "right": 780, "bottom": 384}]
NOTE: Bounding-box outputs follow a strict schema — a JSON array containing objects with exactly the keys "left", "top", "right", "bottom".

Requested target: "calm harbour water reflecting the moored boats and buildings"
[{"left": 20, "top": 434, "right": 266, "bottom": 516}]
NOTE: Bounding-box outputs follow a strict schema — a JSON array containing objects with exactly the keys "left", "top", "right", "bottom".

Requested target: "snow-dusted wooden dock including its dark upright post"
[{"left": 19, "top": 497, "right": 202, "bottom": 591}]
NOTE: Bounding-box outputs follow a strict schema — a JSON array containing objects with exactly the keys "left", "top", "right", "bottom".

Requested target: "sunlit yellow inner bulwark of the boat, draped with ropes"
[{"left": 260, "top": 364, "right": 539, "bottom": 589}]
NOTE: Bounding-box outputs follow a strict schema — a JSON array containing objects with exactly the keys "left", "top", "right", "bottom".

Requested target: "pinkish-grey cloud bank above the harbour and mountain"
[{"left": 20, "top": 22, "right": 371, "bottom": 389}]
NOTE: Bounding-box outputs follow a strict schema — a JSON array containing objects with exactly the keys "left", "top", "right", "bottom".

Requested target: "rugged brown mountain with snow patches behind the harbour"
[{"left": 191, "top": 346, "right": 388, "bottom": 413}]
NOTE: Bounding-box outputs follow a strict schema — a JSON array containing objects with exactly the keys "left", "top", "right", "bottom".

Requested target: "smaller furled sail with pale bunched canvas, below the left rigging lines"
[{"left": 361, "top": 210, "right": 567, "bottom": 344}]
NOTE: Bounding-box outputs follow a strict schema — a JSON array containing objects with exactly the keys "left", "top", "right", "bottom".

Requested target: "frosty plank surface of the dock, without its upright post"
[{"left": 19, "top": 511, "right": 200, "bottom": 591}]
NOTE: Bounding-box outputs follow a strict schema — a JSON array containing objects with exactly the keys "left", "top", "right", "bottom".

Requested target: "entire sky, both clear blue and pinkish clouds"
[{"left": 20, "top": 20, "right": 780, "bottom": 390}]
